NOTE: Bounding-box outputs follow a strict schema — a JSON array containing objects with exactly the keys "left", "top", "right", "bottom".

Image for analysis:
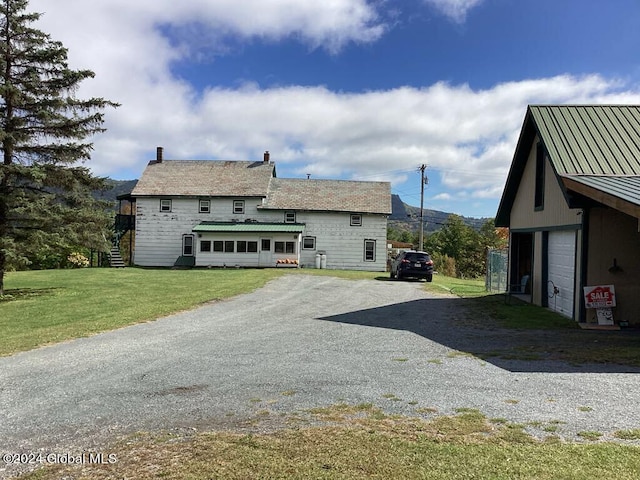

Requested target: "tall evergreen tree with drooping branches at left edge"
[{"left": 0, "top": 0, "right": 117, "bottom": 295}]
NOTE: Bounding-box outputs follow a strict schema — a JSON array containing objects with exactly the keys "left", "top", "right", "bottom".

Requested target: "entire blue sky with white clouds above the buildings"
[{"left": 30, "top": 0, "right": 640, "bottom": 217}]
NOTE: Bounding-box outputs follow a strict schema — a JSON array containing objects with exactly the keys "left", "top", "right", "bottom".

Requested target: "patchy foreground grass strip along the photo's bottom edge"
[{"left": 20, "top": 404, "right": 640, "bottom": 480}]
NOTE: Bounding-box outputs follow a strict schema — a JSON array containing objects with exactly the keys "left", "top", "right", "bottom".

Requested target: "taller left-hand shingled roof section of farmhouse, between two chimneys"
[{"left": 131, "top": 160, "right": 274, "bottom": 197}]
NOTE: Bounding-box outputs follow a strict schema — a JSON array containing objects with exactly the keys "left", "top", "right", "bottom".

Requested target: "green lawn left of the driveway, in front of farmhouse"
[{"left": 0, "top": 268, "right": 283, "bottom": 355}]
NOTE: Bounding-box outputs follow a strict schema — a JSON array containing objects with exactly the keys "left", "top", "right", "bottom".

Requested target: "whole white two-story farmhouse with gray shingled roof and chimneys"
[{"left": 119, "top": 147, "right": 391, "bottom": 271}]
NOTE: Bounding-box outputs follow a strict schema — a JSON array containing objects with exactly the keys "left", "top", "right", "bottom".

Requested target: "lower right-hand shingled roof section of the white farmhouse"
[{"left": 259, "top": 178, "right": 391, "bottom": 215}]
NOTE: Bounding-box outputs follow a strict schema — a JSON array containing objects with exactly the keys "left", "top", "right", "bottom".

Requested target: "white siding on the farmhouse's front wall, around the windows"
[{"left": 134, "top": 197, "right": 387, "bottom": 272}]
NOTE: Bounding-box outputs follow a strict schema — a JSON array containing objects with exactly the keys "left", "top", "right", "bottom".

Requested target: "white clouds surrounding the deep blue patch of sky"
[{"left": 22, "top": 0, "right": 640, "bottom": 209}]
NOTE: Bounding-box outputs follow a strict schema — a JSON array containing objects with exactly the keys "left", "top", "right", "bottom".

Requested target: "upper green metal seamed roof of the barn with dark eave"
[{"left": 496, "top": 105, "right": 640, "bottom": 227}]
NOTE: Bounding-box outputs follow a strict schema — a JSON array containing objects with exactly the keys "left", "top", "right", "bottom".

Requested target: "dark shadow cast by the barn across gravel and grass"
[{"left": 318, "top": 298, "right": 640, "bottom": 373}]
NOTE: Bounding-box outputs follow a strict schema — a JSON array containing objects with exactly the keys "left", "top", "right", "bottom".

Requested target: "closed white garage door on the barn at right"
[{"left": 547, "top": 230, "right": 576, "bottom": 317}]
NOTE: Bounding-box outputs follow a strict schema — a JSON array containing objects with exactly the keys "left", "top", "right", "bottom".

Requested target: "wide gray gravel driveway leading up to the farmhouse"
[{"left": 0, "top": 275, "right": 640, "bottom": 477}]
